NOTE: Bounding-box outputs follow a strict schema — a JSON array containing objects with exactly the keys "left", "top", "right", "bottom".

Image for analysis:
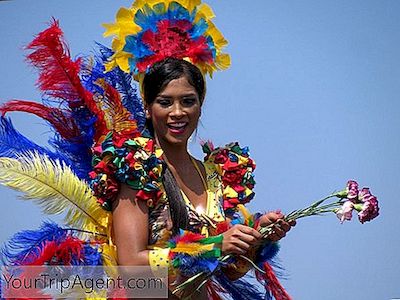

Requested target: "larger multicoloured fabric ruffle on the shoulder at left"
[{"left": 89, "top": 132, "right": 165, "bottom": 211}]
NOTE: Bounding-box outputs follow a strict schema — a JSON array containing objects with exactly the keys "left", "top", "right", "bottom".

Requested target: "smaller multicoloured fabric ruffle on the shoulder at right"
[{"left": 202, "top": 142, "right": 256, "bottom": 212}]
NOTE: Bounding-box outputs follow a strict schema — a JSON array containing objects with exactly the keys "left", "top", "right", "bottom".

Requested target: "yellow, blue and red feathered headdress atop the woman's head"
[{"left": 104, "top": 0, "right": 230, "bottom": 81}]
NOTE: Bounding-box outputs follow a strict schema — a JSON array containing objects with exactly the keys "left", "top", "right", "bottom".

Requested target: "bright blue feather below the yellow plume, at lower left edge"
[{"left": 1, "top": 221, "right": 67, "bottom": 266}]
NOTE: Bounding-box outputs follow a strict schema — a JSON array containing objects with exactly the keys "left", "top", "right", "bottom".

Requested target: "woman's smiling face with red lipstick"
[{"left": 146, "top": 77, "right": 201, "bottom": 145}]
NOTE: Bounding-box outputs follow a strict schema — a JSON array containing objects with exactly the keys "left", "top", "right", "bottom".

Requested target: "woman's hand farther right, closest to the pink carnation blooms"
[{"left": 259, "top": 212, "right": 296, "bottom": 242}]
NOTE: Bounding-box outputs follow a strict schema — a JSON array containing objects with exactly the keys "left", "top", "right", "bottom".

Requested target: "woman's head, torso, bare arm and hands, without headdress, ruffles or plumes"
[{"left": 109, "top": 58, "right": 294, "bottom": 298}]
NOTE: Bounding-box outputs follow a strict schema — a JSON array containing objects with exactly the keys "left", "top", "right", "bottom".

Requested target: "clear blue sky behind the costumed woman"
[{"left": 0, "top": 0, "right": 400, "bottom": 300}]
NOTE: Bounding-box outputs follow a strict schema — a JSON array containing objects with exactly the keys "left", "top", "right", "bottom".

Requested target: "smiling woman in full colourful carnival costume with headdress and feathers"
[{"left": 1, "top": 0, "right": 294, "bottom": 299}]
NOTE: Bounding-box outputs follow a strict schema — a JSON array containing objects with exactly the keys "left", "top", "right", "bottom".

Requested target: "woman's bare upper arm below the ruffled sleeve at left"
[{"left": 113, "top": 184, "right": 149, "bottom": 266}]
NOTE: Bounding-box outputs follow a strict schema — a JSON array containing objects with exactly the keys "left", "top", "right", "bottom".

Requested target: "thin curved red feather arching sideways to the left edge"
[{"left": 0, "top": 100, "right": 79, "bottom": 140}]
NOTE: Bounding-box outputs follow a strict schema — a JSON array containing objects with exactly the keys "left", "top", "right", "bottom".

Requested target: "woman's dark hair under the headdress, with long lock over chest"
[{"left": 142, "top": 58, "right": 206, "bottom": 234}]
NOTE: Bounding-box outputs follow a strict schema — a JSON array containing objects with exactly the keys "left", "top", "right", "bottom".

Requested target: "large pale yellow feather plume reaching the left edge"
[{"left": 0, "top": 153, "right": 109, "bottom": 235}]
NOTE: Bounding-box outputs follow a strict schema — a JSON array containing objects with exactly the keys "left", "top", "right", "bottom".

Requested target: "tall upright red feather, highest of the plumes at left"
[{"left": 26, "top": 20, "right": 107, "bottom": 138}]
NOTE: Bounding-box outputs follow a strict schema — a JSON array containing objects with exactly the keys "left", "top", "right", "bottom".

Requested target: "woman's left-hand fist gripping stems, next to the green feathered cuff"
[{"left": 221, "top": 224, "right": 261, "bottom": 254}]
